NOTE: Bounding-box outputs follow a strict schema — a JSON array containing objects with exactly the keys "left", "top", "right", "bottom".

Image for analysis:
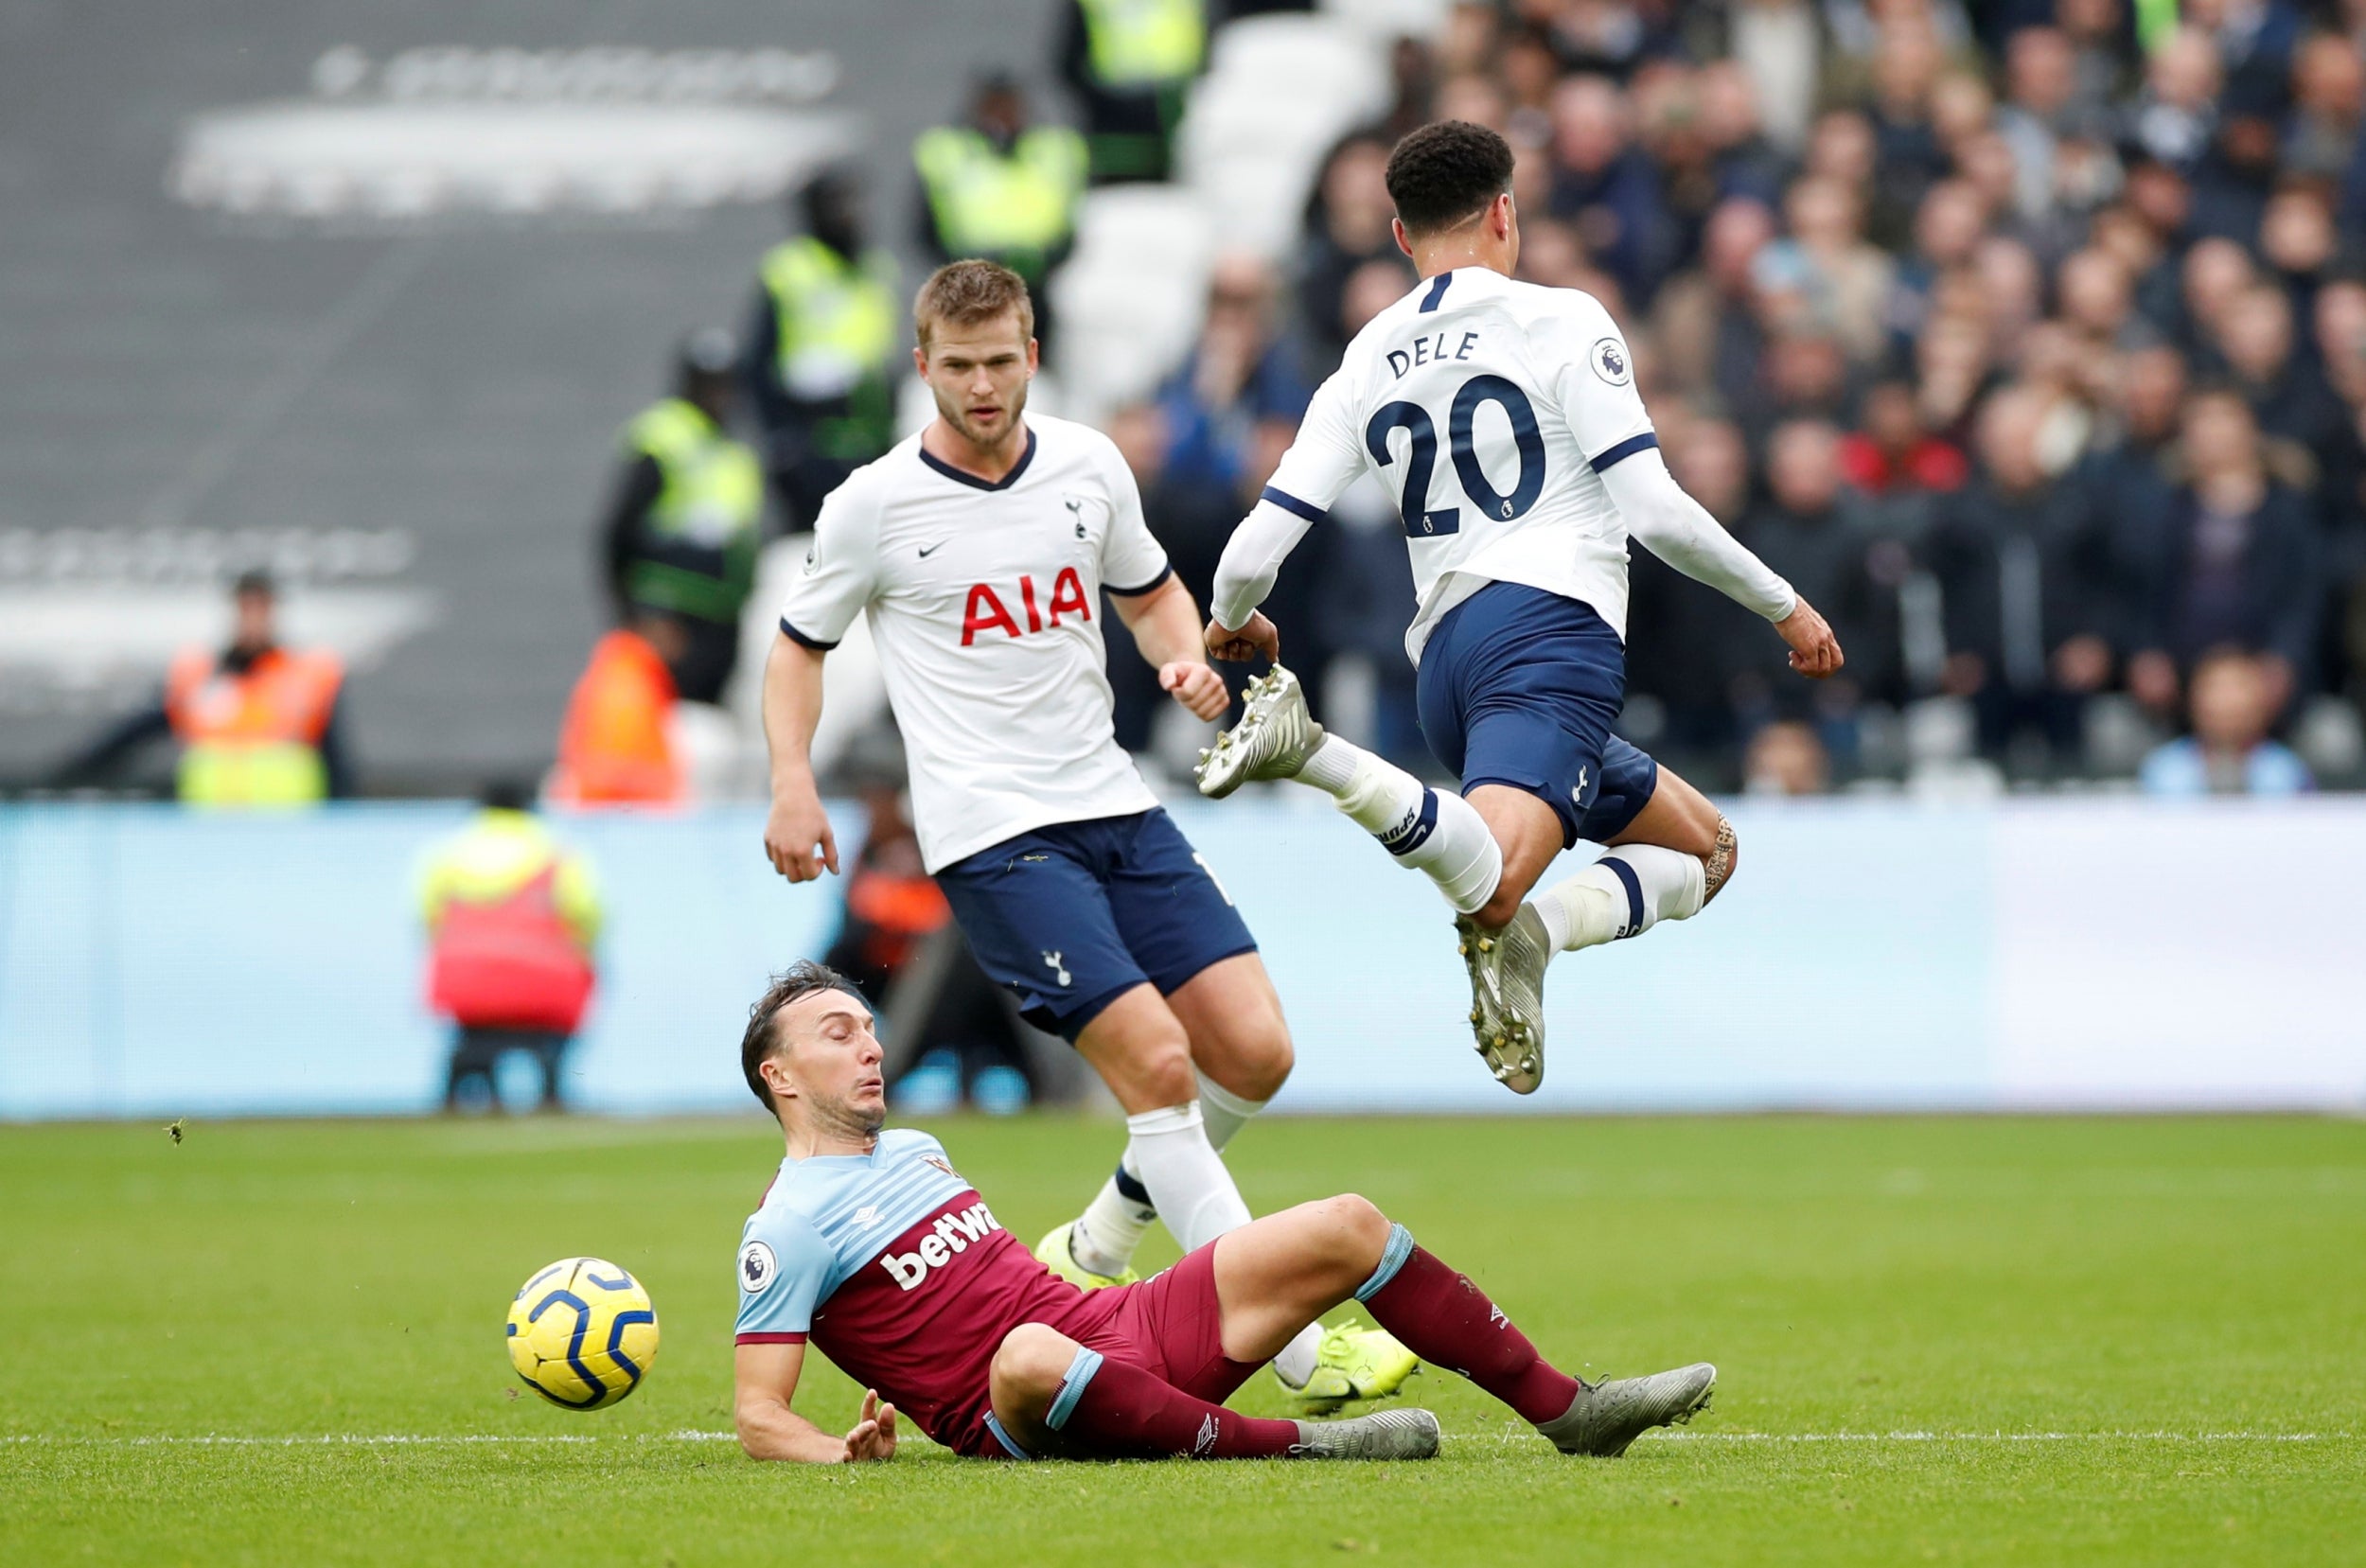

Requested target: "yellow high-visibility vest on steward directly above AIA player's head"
[{"left": 911, "top": 125, "right": 1086, "bottom": 284}]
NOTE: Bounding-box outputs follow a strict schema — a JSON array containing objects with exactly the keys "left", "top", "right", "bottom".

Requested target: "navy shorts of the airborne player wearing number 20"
[{"left": 1418, "top": 582, "right": 1659, "bottom": 849}]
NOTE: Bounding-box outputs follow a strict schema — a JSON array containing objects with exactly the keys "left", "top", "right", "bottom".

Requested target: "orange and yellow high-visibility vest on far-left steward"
[{"left": 164, "top": 648, "right": 345, "bottom": 806}]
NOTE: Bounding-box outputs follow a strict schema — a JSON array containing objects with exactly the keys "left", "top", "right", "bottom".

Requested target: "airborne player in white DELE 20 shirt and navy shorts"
[{"left": 1200, "top": 120, "right": 1841, "bottom": 1095}]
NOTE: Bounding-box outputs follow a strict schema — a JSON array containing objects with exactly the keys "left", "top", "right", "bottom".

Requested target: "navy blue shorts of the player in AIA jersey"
[{"left": 937, "top": 809, "right": 1257, "bottom": 1043}]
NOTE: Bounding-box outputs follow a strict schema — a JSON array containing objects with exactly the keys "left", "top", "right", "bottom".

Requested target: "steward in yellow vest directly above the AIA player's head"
[{"left": 911, "top": 76, "right": 1088, "bottom": 345}]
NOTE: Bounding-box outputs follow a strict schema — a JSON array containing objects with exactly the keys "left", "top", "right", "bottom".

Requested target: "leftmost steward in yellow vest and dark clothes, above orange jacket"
[{"left": 604, "top": 328, "right": 765, "bottom": 702}]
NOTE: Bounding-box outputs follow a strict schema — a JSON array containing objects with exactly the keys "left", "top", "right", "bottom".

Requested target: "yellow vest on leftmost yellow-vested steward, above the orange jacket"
[{"left": 625, "top": 397, "right": 765, "bottom": 622}]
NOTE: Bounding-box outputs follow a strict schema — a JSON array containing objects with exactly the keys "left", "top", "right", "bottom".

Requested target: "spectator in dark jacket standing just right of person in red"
[{"left": 1926, "top": 385, "right": 2110, "bottom": 759}]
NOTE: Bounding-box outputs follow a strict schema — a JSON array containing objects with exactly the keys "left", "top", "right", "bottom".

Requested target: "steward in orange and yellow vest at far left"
[{"left": 50, "top": 570, "right": 353, "bottom": 809}]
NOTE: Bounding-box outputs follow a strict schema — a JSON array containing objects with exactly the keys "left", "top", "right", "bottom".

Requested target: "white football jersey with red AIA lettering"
[{"left": 781, "top": 414, "right": 1172, "bottom": 872}]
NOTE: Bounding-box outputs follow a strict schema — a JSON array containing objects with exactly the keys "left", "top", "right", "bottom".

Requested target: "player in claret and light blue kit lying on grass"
[{"left": 733, "top": 962, "right": 1718, "bottom": 1464}]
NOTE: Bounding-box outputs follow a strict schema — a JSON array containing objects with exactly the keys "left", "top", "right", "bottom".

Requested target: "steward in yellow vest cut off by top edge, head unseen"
[{"left": 1060, "top": 0, "right": 1207, "bottom": 185}]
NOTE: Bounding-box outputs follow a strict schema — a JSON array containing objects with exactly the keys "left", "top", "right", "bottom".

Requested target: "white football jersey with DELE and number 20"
[{"left": 1263, "top": 267, "right": 1659, "bottom": 662}]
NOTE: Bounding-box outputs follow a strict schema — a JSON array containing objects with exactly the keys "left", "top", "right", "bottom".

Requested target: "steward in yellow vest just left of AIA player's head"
[{"left": 741, "top": 170, "right": 904, "bottom": 532}]
